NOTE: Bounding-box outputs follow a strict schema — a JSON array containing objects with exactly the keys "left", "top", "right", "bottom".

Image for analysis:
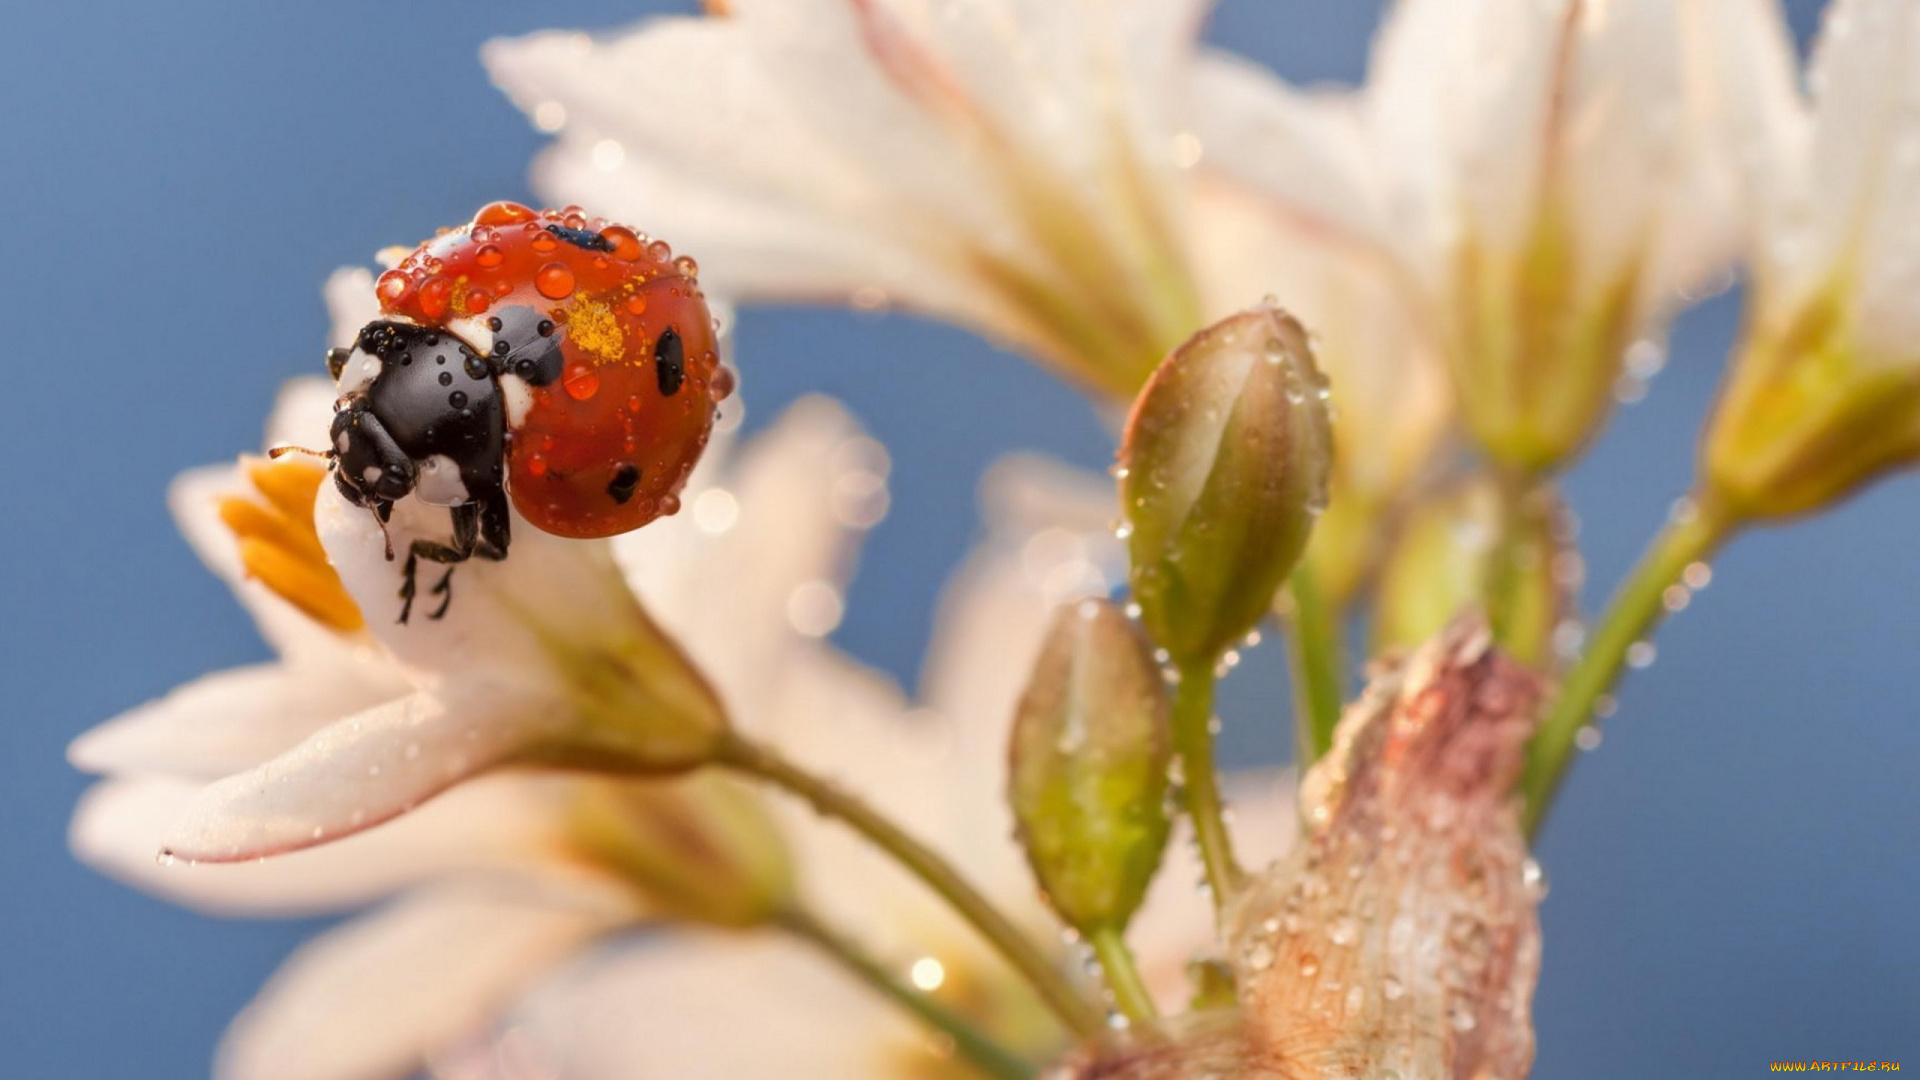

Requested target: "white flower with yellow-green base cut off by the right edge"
[{"left": 1703, "top": 0, "right": 1920, "bottom": 519}]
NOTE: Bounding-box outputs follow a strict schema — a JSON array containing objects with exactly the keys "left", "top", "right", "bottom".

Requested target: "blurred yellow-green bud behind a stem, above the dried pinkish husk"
[{"left": 1373, "top": 477, "right": 1578, "bottom": 671}]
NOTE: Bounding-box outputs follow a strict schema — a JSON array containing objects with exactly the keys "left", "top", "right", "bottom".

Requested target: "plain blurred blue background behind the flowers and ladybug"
[{"left": 0, "top": 0, "right": 1920, "bottom": 1080}]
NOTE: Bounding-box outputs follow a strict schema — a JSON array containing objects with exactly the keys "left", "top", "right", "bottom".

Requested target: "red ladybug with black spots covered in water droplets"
[{"left": 326, "top": 202, "right": 733, "bottom": 623}]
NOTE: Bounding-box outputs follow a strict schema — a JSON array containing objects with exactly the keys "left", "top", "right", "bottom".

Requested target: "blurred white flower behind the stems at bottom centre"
[{"left": 447, "top": 459, "right": 1294, "bottom": 1080}]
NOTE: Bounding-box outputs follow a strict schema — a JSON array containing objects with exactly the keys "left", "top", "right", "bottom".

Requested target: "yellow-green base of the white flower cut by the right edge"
[{"left": 1703, "top": 290, "right": 1920, "bottom": 519}]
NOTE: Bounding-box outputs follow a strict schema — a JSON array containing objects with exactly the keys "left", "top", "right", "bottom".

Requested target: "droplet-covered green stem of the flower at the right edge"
[{"left": 1521, "top": 502, "right": 1740, "bottom": 834}]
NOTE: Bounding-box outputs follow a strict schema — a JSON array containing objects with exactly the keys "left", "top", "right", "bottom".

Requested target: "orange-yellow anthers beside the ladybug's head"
[{"left": 219, "top": 455, "right": 367, "bottom": 634}]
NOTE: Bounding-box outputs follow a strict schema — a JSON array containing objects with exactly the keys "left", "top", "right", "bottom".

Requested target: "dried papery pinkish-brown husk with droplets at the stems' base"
[{"left": 1062, "top": 619, "right": 1544, "bottom": 1080}]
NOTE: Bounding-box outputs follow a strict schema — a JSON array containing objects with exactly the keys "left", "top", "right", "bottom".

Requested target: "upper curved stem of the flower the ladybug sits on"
[{"left": 716, "top": 734, "right": 1106, "bottom": 1036}]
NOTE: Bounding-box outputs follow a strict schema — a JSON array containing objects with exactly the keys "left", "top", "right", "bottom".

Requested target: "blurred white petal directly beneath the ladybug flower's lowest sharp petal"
[{"left": 69, "top": 774, "right": 563, "bottom": 917}]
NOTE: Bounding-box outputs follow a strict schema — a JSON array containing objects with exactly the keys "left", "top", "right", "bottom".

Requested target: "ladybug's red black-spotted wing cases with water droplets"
[{"left": 376, "top": 202, "right": 732, "bottom": 538}]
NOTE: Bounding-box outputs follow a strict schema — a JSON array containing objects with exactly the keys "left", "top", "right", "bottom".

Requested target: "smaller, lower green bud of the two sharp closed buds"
[{"left": 1008, "top": 600, "right": 1173, "bottom": 934}]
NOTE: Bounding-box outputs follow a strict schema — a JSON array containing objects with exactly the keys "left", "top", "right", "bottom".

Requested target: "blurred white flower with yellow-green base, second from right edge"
[{"left": 1194, "top": 0, "right": 1740, "bottom": 469}]
